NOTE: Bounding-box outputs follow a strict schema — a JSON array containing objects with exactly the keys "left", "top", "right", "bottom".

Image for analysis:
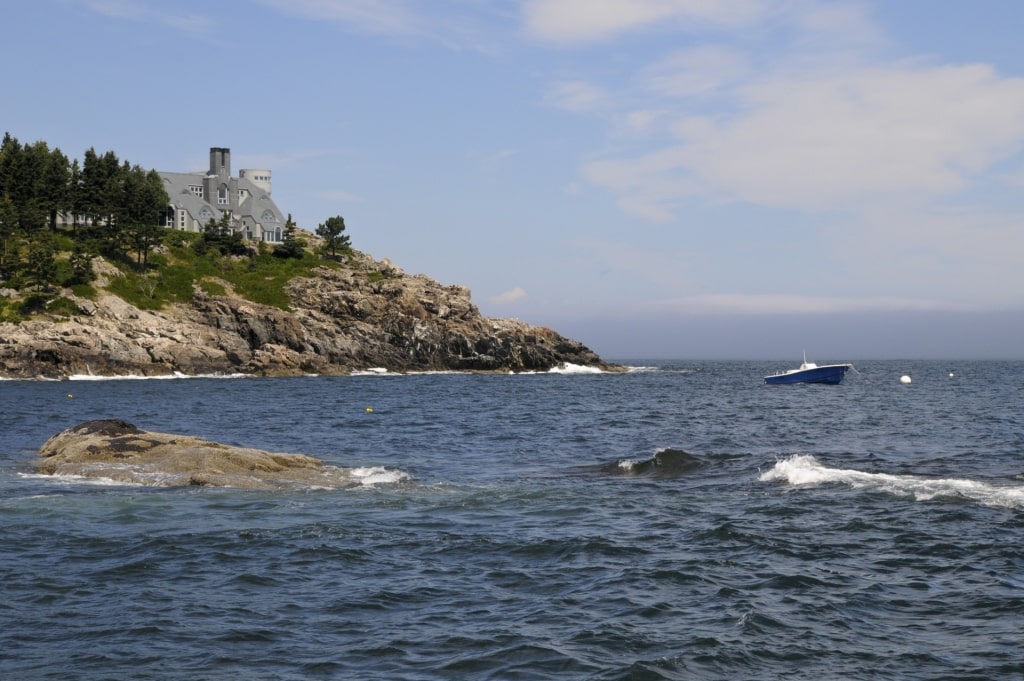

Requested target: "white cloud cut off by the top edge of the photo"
[{"left": 522, "top": 0, "right": 767, "bottom": 44}]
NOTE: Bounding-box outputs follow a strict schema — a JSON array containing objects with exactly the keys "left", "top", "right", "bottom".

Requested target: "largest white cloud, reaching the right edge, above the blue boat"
[{"left": 584, "top": 63, "right": 1024, "bottom": 220}]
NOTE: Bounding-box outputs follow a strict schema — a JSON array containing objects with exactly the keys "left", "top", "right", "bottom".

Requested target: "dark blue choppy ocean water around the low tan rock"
[{"left": 0, "top": 361, "right": 1024, "bottom": 681}]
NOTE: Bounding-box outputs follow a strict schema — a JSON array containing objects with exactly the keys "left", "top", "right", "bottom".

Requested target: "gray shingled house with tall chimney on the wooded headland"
[{"left": 157, "top": 146, "right": 285, "bottom": 243}]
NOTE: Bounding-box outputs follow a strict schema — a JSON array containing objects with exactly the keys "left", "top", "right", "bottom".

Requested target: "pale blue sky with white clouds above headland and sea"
[{"left": 6, "top": 0, "right": 1024, "bottom": 366}]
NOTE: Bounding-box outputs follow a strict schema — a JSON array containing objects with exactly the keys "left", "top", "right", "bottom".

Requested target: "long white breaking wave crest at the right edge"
[{"left": 760, "top": 455, "right": 1024, "bottom": 509}]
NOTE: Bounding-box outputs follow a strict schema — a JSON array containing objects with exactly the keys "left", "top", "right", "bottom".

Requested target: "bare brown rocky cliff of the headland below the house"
[{"left": 0, "top": 254, "right": 620, "bottom": 378}]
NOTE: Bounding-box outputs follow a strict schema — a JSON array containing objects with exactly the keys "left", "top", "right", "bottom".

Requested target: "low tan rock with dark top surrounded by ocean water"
[{"left": 38, "top": 420, "right": 358, "bottom": 488}]
